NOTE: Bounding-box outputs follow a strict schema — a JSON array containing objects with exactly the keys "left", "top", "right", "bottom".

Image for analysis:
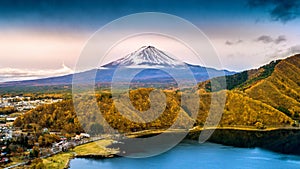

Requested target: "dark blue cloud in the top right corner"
[{"left": 248, "top": 0, "right": 300, "bottom": 23}]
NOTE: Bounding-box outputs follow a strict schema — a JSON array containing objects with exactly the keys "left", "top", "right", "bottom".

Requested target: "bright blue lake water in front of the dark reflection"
[{"left": 70, "top": 141, "right": 300, "bottom": 169}]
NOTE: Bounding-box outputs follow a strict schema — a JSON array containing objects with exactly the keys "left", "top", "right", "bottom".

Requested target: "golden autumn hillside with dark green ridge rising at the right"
[{"left": 199, "top": 55, "right": 300, "bottom": 125}]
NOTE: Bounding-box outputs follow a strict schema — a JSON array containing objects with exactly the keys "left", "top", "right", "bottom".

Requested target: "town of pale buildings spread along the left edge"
[{"left": 0, "top": 95, "right": 63, "bottom": 164}]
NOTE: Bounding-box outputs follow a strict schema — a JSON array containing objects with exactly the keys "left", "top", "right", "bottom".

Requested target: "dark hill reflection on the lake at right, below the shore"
[{"left": 187, "top": 128, "right": 300, "bottom": 155}]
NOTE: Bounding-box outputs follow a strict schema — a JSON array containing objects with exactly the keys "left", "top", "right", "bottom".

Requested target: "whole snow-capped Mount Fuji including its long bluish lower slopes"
[{"left": 0, "top": 46, "right": 236, "bottom": 87}]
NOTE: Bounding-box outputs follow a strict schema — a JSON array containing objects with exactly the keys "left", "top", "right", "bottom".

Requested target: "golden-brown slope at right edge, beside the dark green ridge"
[{"left": 245, "top": 55, "right": 300, "bottom": 119}]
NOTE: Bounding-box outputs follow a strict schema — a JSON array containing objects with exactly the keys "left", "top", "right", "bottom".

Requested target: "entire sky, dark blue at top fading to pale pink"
[{"left": 0, "top": 0, "right": 300, "bottom": 82}]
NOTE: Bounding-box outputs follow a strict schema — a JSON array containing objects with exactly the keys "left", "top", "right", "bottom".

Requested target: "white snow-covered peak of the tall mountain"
[{"left": 103, "top": 46, "right": 185, "bottom": 67}]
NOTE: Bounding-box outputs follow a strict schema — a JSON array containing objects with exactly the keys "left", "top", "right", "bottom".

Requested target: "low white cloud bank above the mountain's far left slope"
[{"left": 0, "top": 64, "right": 73, "bottom": 82}]
